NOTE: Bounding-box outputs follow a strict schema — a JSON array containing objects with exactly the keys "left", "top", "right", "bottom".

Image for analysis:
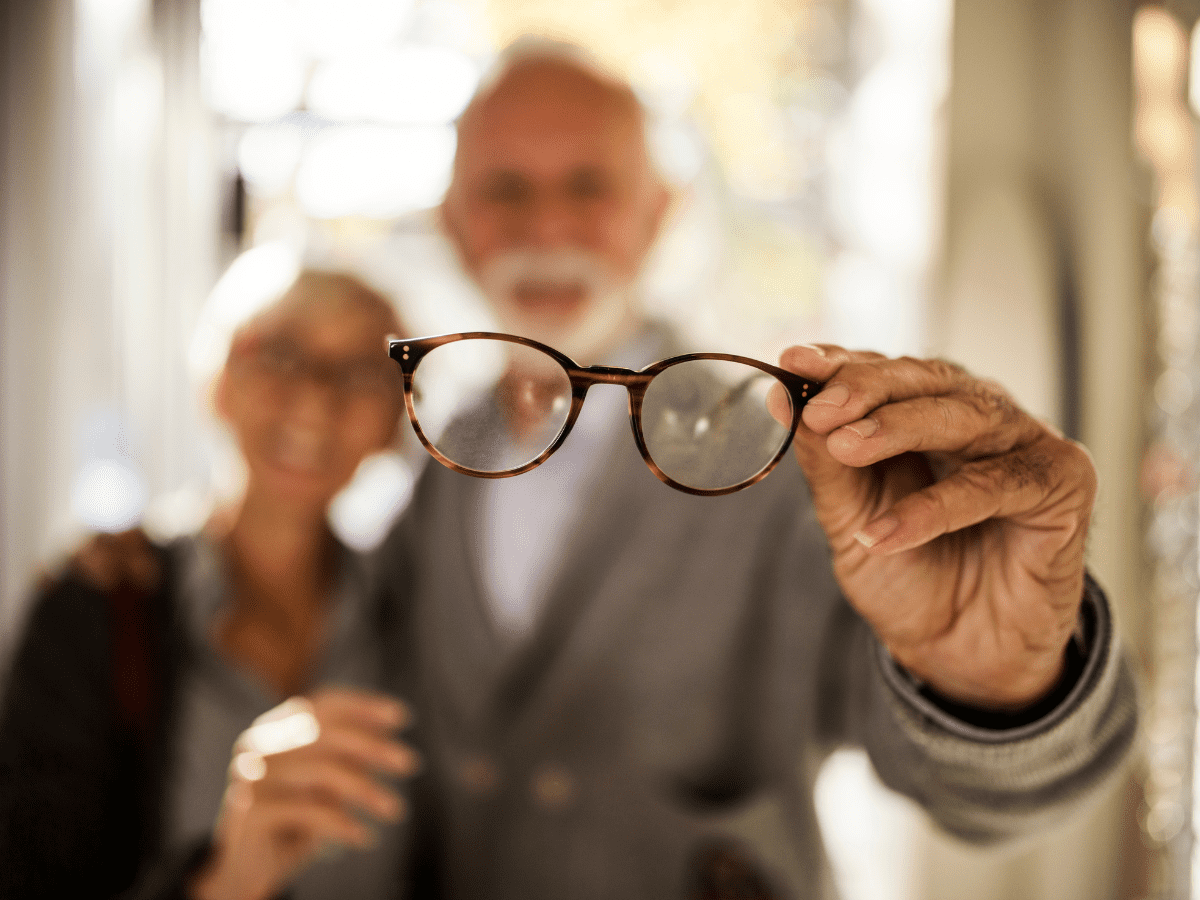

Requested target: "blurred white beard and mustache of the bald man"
[{"left": 479, "top": 250, "right": 635, "bottom": 365}]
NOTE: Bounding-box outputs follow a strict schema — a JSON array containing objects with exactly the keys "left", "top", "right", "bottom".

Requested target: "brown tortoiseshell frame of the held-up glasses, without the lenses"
[{"left": 388, "top": 331, "right": 824, "bottom": 497}]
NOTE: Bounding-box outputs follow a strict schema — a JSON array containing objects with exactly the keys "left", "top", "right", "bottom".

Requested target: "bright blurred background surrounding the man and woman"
[{"left": 0, "top": 0, "right": 1200, "bottom": 900}]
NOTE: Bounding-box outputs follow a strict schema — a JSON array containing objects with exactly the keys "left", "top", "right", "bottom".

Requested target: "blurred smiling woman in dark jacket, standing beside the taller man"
[{"left": 0, "top": 271, "right": 415, "bottom": 900}]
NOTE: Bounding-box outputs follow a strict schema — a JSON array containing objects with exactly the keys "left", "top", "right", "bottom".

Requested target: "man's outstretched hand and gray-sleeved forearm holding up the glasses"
[{"left": 782, "top": 346, "right": 1136, "bottom": 840}]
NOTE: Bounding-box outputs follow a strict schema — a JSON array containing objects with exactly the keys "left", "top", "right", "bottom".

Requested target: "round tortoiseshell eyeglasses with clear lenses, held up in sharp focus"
[{"left": 389, "top": 331, "right": 822, "bottom": 496}]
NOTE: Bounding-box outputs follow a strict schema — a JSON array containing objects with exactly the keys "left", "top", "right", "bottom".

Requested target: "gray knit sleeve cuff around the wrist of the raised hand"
[{"left": 864, "top": 578, "right": 1138, "bottom": 842}]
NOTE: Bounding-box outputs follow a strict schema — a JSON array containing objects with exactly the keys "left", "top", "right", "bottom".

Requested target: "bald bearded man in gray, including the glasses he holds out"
[{"left": 372, "top": 38, "right": 1135, "bottom": 899}]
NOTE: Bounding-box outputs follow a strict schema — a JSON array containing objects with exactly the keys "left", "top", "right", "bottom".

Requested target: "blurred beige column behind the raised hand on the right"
[{"left": 920, "top": 0, "right": 1150, "bottom": 900}]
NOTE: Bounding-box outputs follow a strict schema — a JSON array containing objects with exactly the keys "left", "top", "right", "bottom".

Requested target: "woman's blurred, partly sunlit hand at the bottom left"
[{"left": 191, "top": 689, "right": 418, "bottom": 900}]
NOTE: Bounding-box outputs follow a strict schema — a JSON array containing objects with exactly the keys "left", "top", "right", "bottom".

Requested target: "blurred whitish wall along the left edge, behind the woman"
[{"left": 0, "top": 0, "right": 218, "bottom": 660}]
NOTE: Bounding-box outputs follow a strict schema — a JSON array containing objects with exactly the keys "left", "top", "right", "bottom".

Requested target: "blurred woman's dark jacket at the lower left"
[{"left": 0, "top": 545, "right": 428, "bottom": 900}]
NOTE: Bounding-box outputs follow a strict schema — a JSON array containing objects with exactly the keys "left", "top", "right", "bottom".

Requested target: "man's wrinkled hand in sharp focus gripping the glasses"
[{"left": 780, "top": 346, "right": 1097, "bottom": 710}]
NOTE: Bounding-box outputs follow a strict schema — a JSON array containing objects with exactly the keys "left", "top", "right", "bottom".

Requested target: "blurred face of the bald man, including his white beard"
[{"left": 443, "top": 61, "right": 667, "bottom": 362}]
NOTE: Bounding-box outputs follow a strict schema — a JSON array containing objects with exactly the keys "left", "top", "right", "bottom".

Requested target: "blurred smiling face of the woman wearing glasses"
[{"left": 217, "top": 276, "right": 402, "bottom": 512}]
